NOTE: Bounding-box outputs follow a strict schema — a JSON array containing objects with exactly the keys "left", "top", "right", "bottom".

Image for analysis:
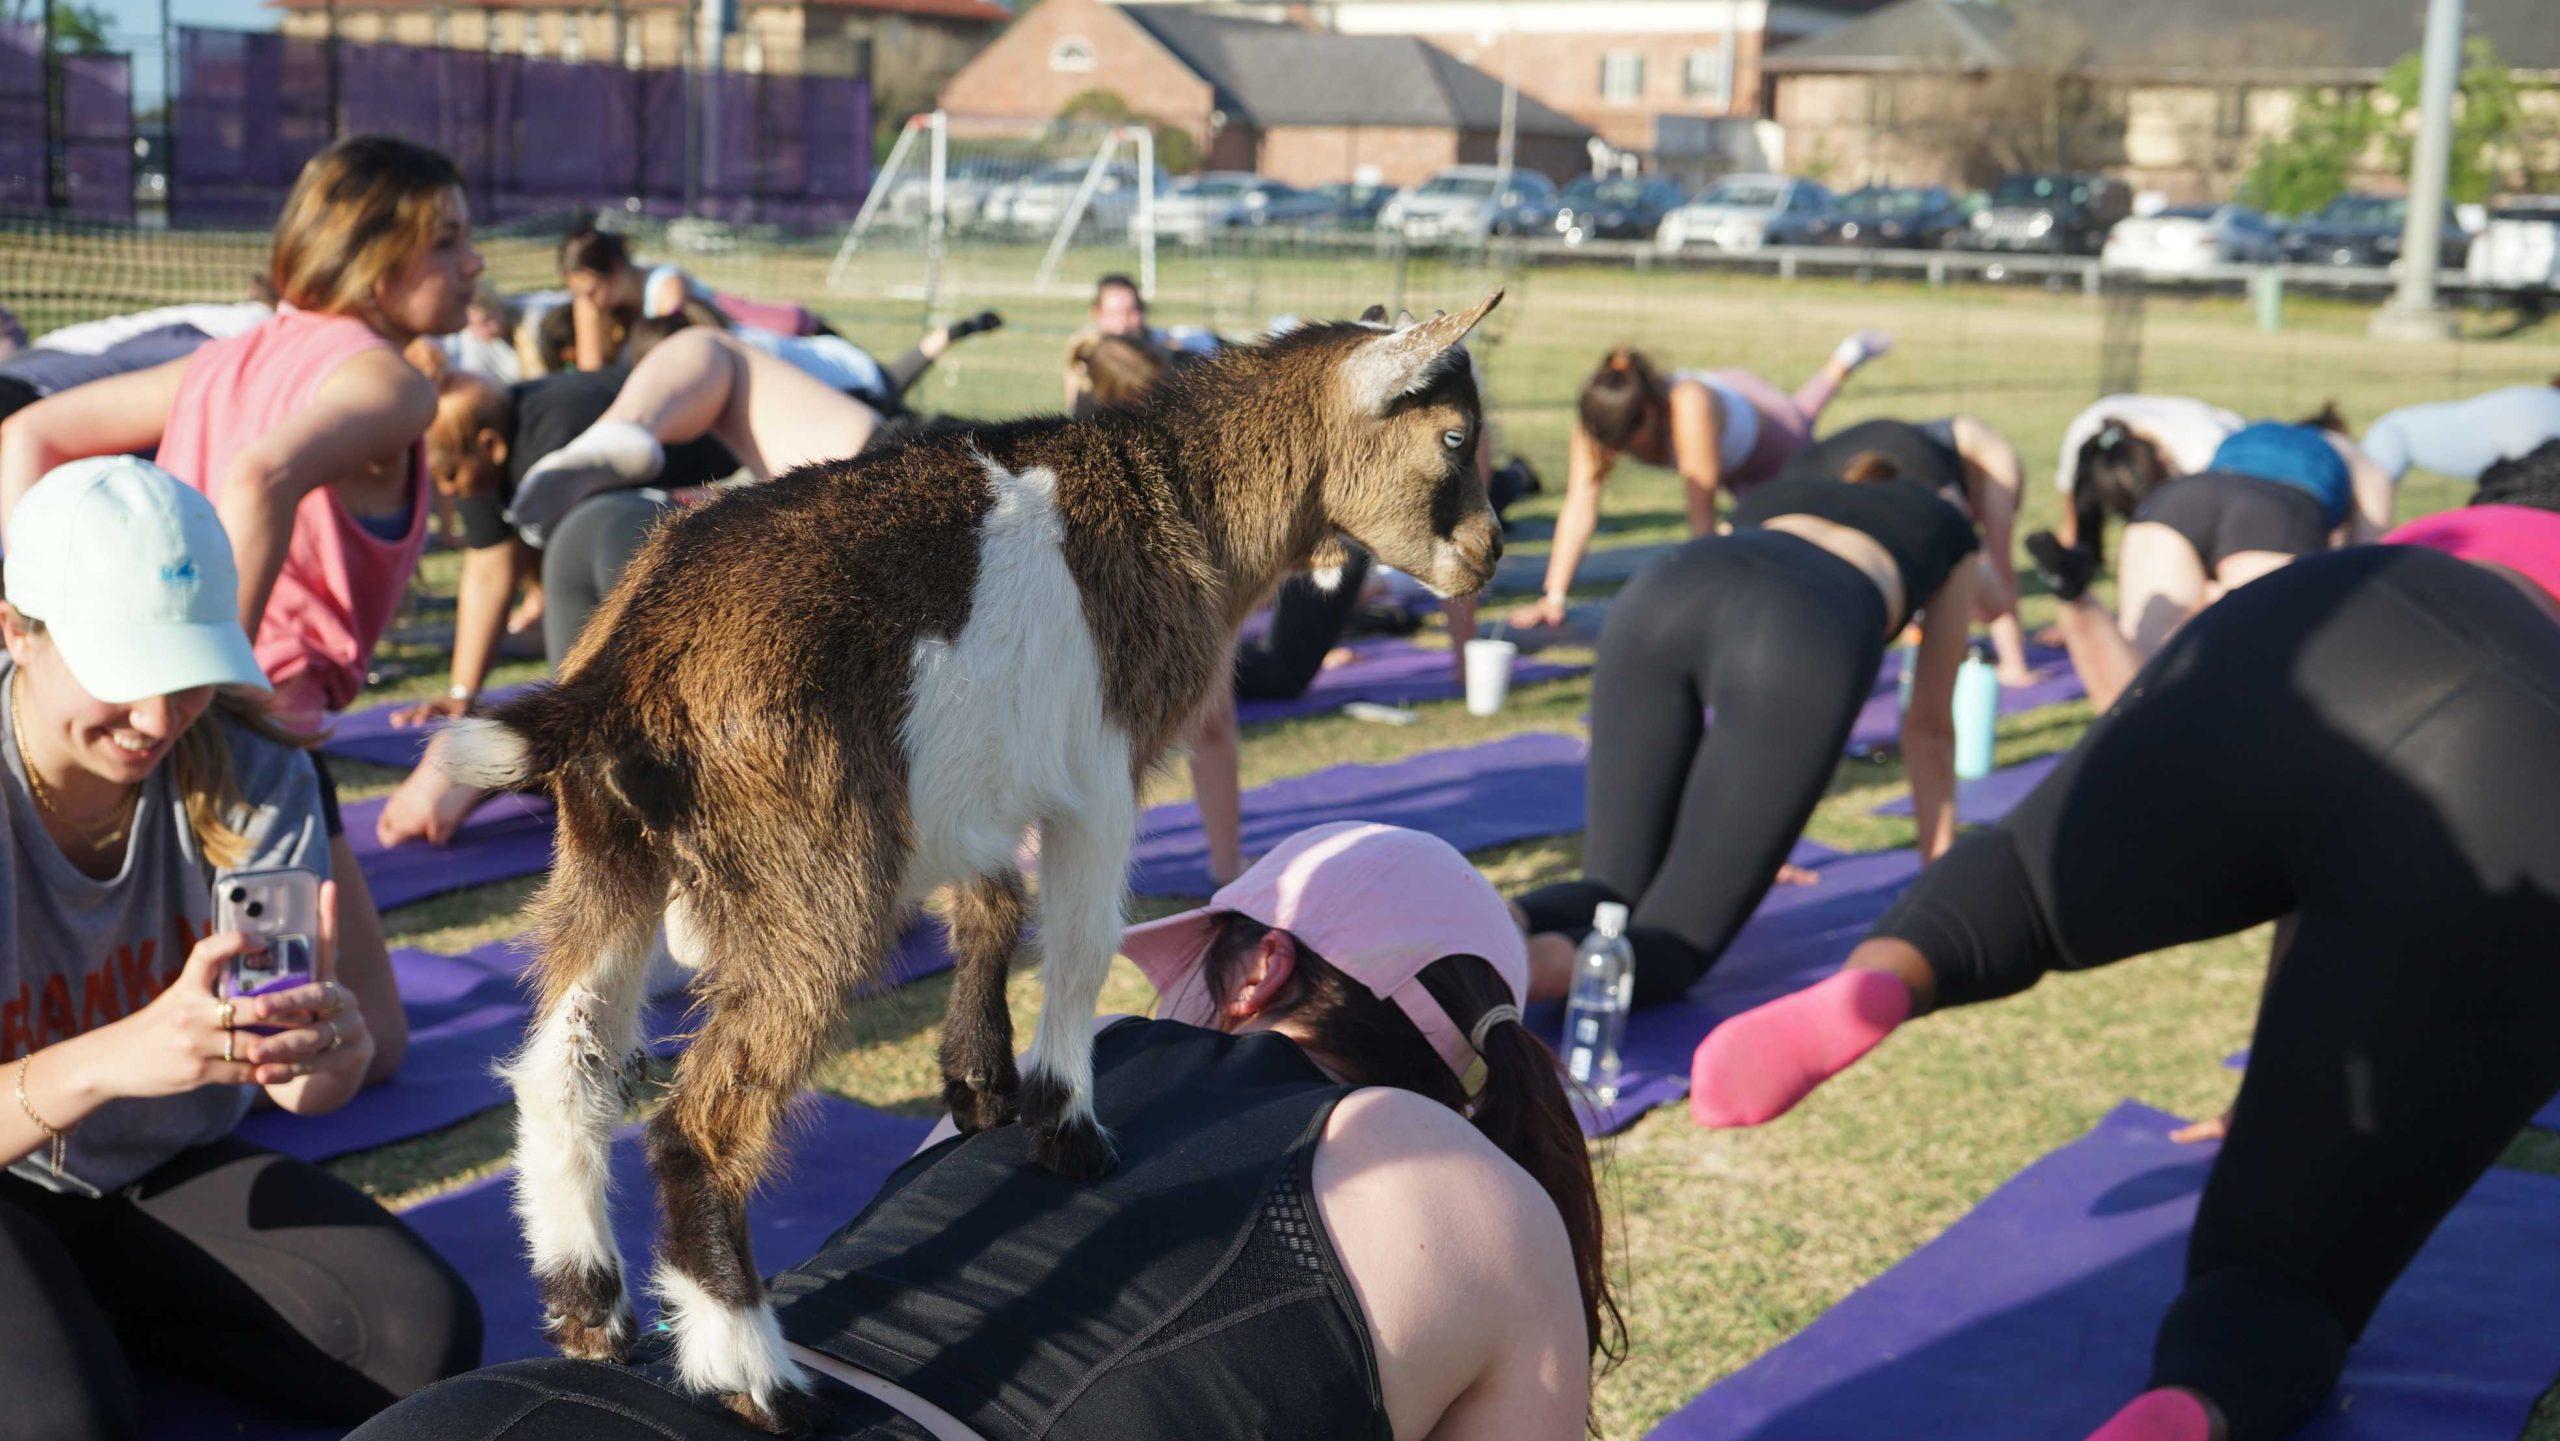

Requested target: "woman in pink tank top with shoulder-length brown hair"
[{"left": 0, "top": 136, "right": 481, "bottom": 1072}]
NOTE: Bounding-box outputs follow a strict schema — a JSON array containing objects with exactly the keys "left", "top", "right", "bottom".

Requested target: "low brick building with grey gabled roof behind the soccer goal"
[{"left": 942, "top": 0, "right": 1590, "bottom": 184}]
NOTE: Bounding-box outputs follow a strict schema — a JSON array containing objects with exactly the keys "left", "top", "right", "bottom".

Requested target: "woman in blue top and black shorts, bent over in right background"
[{"left": 2028, "top": 412, "right": 2391, "bottom": 709}]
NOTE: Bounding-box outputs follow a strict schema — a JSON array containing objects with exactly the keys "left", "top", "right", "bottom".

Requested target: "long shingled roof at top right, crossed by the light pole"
[{"left": 1766, "top": 0, "right": 2560, "bottom": 84}]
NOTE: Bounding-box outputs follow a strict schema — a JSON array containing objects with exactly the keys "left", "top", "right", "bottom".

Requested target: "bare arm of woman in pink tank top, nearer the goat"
[{"left": 215, "top": 351, "right": 435, "bottom": 635}]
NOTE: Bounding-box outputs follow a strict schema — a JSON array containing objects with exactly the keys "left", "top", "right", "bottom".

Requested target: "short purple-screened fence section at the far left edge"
[{"left": 0, "top": 26, "right": 133, "bottom": 220}]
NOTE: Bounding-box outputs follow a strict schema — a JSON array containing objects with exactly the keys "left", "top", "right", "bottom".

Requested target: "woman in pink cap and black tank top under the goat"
[{"left": 351, "top": 824, "right": 1623, "bottom": 1441}]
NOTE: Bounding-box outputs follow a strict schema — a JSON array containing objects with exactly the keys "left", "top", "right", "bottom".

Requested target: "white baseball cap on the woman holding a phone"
[{"left": 5, "top": 456, "right": 269, "bottom": 706}]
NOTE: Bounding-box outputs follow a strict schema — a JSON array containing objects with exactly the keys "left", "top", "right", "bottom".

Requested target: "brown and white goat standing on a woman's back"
[{"left": 445, "top": 294, "right": 1503, "bottom": 1431}]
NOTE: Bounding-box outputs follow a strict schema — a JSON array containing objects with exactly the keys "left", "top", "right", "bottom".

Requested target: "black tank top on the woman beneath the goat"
[{"left": 773, "top": 1021, "right": 1393, "bottom": 1441}]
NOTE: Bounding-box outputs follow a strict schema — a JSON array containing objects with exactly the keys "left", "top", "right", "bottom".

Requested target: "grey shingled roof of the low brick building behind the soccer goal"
[{"left": 1121, "top": 5, "right": 1590, "bottom": 138}]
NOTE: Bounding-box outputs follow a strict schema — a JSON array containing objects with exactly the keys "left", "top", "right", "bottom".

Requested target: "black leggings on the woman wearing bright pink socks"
[{"left": 1876, "top": 545, "right": 2560, "bottom": 1441}]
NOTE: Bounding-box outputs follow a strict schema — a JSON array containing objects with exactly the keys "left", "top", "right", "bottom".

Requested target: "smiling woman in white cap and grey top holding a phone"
[{"left": 0, "top": 458, "right": 479, "bottom": 1441}]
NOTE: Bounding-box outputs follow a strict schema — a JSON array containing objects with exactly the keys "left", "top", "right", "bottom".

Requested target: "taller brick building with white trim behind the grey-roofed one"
[{"left": 1119, "top": 0, "right": 1884, "bottom": 174}]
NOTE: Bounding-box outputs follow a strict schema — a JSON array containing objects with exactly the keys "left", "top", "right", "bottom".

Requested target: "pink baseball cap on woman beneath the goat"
[{"left": 1121, "top": 822, "right": 1528, "bottom": 1080}]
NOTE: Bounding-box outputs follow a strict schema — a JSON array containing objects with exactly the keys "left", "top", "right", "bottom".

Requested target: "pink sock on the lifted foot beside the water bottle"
[{"left": 1690, "top": 970, "right": 1912, "bottom": 1129}]
